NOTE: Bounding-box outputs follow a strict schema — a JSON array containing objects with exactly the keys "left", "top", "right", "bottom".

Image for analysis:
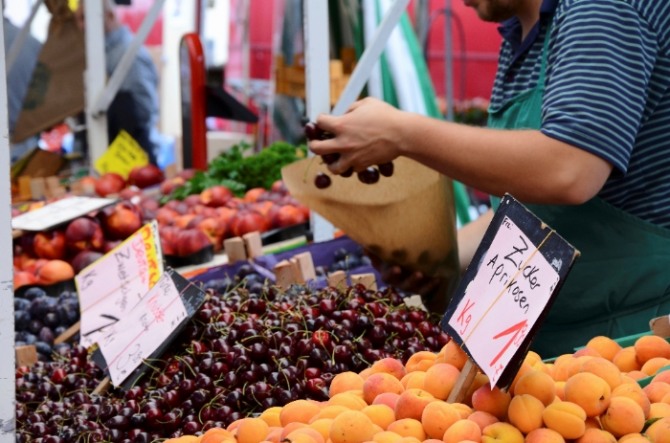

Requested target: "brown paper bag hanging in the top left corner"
[{"left": 12, "top": 0, "right": 86, "bottom": 143}]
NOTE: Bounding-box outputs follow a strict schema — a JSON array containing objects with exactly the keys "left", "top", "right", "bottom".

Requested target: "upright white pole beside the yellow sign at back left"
[{"left": 84, "top": 0, "right": 109, "bottom": 172}]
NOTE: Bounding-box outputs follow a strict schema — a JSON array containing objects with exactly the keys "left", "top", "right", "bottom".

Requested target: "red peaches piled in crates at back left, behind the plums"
[{"left": 14, "top": 167, "right": 309, "bottom": 289}]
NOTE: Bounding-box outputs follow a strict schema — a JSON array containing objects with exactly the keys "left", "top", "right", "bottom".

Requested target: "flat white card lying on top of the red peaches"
[{"left": 12, "top": 197, "right": 116, "bottom": 231}]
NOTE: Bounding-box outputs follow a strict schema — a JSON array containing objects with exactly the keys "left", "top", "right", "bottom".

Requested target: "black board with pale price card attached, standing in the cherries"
[{"left": 93, "top": 268, "right": 206, "bottom": 389}]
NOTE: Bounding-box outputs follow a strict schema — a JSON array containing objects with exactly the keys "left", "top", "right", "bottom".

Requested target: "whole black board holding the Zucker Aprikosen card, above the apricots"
[{"left": 442, "top": 195, "right": 579, "bottom": 388}]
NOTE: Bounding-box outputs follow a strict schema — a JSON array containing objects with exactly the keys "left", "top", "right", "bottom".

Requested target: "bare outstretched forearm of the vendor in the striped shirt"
[{"left": 398, "top": 113, "right": 611, "bottom": 204}]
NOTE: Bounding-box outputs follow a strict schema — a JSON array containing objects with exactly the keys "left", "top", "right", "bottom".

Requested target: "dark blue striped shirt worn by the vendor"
[{"left": 491, "top": 0, "right": 670, "bottom": 228}]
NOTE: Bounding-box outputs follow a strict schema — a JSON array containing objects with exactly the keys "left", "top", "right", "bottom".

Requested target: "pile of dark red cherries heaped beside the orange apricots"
[{"left": 16, "top": 269, "right": 448, "bottom": 443}]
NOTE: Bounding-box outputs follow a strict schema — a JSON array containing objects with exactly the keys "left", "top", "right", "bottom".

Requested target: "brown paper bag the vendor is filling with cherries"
[{"left": 282, "top": 157, "right": 459, "bottom": 281}]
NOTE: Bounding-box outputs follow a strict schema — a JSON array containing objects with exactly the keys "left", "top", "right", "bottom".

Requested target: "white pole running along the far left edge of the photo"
[{"left": 0, "top": 12, "right": 16, "bottom": 443}]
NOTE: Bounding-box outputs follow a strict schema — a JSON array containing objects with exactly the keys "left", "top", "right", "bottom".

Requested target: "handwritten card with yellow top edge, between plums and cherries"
[{"left": 75, "top": 221, "right": 163, "bottom": 347}]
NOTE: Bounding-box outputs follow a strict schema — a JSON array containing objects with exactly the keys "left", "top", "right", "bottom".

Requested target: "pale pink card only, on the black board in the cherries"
[{"left": 98, "top": 273, "right": 188, "bottom": 386}]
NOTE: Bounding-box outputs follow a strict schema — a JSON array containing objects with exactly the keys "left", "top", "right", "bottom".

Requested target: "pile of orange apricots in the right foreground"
[{"left": 167, "top": 335, "right": 670, "bottom": 443}]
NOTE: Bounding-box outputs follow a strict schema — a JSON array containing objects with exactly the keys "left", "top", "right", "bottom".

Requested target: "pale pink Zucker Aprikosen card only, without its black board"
[{"left": 449, "top": 217, "right": 559, "bottom": 385}]
